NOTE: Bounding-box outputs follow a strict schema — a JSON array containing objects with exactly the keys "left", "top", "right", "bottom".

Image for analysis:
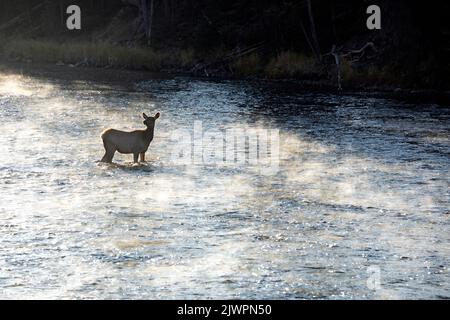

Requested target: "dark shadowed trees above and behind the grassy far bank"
[{"left": 0, "top": 0, "right": 450, "bottom": 88}]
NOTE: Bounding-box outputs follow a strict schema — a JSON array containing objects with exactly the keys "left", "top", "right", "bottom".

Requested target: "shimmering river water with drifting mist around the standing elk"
[{"left": 0, "top": 69, "right": 450, "bottom": 299}]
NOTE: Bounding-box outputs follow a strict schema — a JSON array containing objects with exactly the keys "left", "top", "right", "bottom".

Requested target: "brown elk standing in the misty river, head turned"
[{"left": 100, "top": 112, "right": 159, "bottom": 163}]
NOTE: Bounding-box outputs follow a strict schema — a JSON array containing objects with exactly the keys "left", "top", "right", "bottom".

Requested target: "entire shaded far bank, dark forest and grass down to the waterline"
[{"left": 0, "top": 0, "right": 450, "bottom": 89}]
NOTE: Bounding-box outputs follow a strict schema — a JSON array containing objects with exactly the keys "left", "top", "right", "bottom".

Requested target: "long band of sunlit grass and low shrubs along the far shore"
[{"left": 0, "top": 39, "right": 440, "bottom": 90}]
